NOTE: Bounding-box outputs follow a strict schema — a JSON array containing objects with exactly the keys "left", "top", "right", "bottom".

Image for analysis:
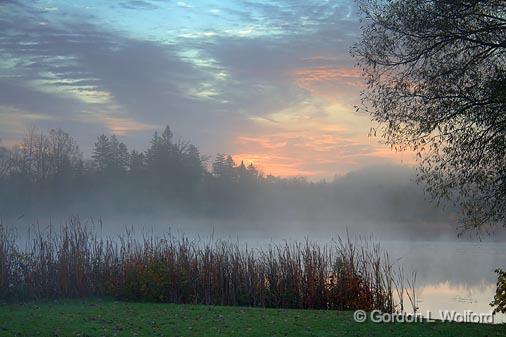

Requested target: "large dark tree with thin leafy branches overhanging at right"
[{"left": 352, "top": 0, "right": 506, "bottom": 230}]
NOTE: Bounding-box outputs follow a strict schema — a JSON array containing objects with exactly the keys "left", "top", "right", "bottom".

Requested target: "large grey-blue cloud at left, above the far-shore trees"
[{"left": 0, "top": 5, "right": 227, "bottom": 151}]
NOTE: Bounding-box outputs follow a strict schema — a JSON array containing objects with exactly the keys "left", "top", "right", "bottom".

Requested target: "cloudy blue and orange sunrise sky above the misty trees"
[{"left": 0, "top": 0, "right": 414, "bottom": 180}]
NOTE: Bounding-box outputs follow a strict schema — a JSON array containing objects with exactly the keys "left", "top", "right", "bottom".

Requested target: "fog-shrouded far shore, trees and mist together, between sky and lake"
[{"left": 0, "top": 128, "right": 456, "bottom": 240}]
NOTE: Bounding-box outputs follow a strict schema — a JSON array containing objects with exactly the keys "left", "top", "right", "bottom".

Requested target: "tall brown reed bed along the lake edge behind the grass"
[{"left": 0, "top": 218, "right": 406, "bottom": 312}]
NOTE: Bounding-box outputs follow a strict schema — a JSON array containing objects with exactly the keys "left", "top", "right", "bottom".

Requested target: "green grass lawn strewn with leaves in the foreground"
[{"left": 0, "top": 300, "right": 506, "bottom": 337}]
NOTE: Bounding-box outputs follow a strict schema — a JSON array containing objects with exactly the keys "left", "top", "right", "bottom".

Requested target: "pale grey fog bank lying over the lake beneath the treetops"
[{"left": 0, "top": 165, "right": 457, "bottom": 236}]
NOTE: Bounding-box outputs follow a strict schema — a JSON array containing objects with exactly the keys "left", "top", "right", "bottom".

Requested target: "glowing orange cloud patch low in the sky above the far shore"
[{"left": 229, "top": 90, "right": 415, "bottom": 180}]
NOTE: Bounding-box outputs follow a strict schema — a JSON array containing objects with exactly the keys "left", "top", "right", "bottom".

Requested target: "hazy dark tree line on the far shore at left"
[{"left": 0, "top": 126, "right": 312, "bottom": 215}]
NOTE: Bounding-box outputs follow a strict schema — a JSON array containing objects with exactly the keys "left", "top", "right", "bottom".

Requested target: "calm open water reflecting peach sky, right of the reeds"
[{"left": 382, "top": 241, "right": 506, "bottom": 323}]
